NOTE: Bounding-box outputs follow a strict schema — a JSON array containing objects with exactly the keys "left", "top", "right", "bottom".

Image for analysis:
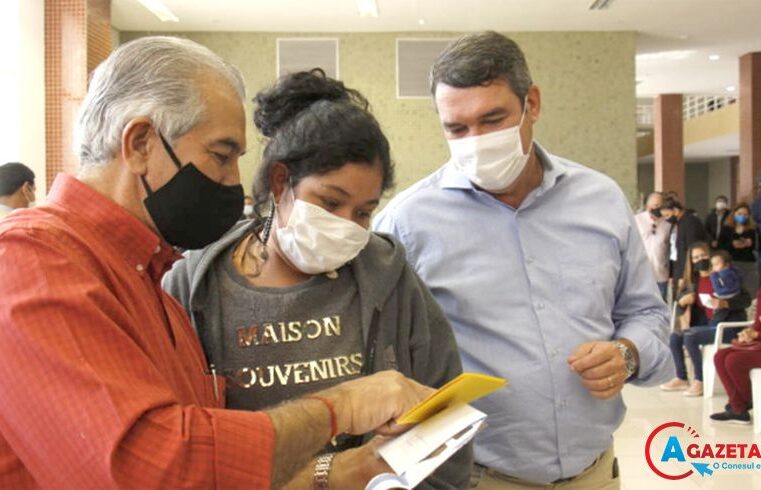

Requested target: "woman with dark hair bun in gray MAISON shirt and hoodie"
[{"left": 164, "top": 69, "right": 471, "bottom": 489}]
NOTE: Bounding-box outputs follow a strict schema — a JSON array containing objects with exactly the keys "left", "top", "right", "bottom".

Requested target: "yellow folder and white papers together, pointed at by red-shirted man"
[{"left": 366, "top": 373, "right": 507, "bottom": 490}]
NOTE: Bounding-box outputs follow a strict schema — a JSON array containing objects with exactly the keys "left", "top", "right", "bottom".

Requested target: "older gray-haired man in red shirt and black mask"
[{"left": 0, "top": 37, "right": 430, "bottom": 489}]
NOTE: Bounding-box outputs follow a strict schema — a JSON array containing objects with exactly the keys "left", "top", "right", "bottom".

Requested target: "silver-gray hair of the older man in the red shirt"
[{"left": 76, "top": 36, "right": 246, "bottom": 165}]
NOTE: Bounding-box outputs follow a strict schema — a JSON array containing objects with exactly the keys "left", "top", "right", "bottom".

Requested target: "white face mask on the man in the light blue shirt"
[{"left": 447, "top": 100, "right": 534, "bottom": 192}]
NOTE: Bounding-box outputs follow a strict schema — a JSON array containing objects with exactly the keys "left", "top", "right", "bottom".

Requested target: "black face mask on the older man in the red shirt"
[{"left": 140, "top": 133, "right": 243, "bottom": 249}]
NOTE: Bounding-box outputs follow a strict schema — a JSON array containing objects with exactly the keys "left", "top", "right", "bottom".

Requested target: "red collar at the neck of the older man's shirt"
[{"left": 48, "top": 174, "right": 181, "bottom": 281}]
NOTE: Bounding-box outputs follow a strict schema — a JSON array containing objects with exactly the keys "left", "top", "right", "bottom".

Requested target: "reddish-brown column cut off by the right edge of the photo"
[{"left": 738, "top": 53, "right": 761, "bottom": 202}]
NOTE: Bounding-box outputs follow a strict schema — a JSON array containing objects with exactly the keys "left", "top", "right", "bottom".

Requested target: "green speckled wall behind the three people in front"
[{"left": 120, "top": 32, "right": 637, "bottom": 202}]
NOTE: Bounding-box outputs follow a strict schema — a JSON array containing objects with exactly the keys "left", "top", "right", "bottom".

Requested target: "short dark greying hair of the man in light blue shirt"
[{"left": 431, "top": 31, "right": 534, "bottom": 104}]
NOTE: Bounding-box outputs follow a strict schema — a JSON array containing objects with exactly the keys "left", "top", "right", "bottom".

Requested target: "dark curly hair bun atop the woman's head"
[{"left": 254, "top": 68, "right": 368, "bottom": 137}]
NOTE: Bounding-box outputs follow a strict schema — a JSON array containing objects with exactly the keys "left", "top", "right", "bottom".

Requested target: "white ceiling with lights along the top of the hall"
[{"left": 112, "top": 0, "right": 761, "bottom": 97}]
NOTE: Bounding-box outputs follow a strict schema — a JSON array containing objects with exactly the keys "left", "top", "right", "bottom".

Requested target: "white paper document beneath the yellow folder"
[{"left": 365, "top": 404, "right": 486, "bottom": 490}]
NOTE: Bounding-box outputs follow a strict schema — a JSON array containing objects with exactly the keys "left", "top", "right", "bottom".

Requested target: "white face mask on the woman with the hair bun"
[{"left": 275, "top": 190, "right": 370, "bottom": 274}]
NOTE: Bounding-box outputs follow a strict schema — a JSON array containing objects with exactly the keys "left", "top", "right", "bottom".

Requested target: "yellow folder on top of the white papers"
[{"left": 397, "top": 373, "right": 507, "bottom": 424}]
